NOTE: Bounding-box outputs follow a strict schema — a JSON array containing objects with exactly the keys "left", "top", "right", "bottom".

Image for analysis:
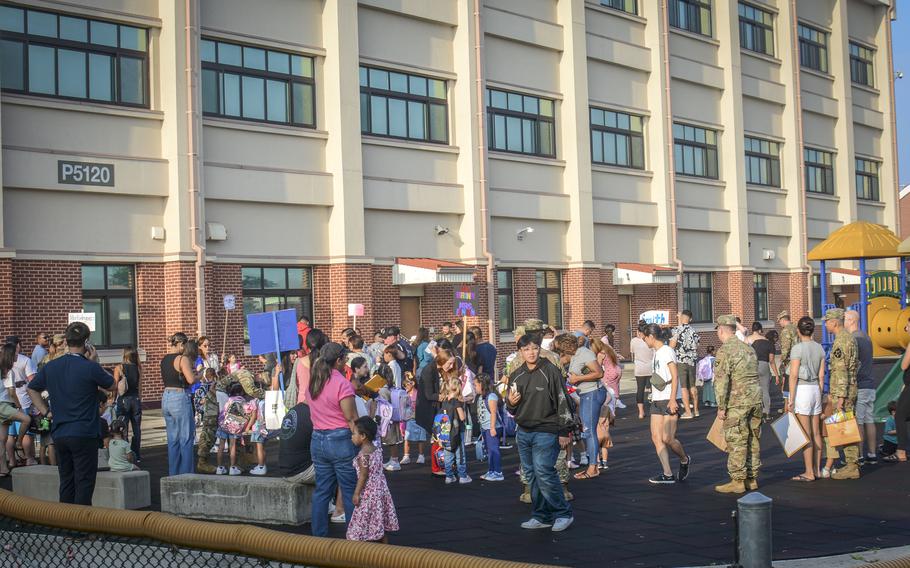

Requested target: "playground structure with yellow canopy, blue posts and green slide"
[{"left": 808, "top": 221, "right": 910, "bottom": 421}]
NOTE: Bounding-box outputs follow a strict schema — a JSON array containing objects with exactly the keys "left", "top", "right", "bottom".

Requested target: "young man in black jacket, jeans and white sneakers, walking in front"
[{"left": 507, "top": 335, "right": 574, "bottom": 532}]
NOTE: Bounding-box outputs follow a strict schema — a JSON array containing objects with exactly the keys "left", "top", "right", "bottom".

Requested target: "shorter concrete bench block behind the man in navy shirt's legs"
[{"left": 13, "top": 465, "right": 152, "bottom": 509}]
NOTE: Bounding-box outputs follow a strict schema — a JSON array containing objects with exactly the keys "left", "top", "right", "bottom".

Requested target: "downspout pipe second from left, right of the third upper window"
[{"left": 474, "top": 0, "right": 497, "bottom": 345}]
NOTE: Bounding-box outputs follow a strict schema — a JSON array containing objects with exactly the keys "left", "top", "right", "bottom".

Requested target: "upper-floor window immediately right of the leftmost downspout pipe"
[{"left": 199, "top": 38, "right": 316, "bottom": 128}]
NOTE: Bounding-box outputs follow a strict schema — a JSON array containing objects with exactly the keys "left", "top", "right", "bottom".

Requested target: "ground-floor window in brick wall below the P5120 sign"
[{"left": 82, "top": 264, "right": 136, "bottom": 349}]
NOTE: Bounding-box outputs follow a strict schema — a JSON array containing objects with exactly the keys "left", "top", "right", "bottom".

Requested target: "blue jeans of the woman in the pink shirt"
[{"left": 310, "top": 428, "right": 357, "bottom": 536}]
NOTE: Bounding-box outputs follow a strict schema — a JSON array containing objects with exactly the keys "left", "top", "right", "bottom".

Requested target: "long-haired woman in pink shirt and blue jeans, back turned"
[{"left": 305, "top": 342, "right": 357, "bottom": 536}]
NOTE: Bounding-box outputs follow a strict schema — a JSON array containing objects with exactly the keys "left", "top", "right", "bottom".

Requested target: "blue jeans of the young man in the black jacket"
[{"left": 515, "top": 428, "right": 572, "bottom": 524}]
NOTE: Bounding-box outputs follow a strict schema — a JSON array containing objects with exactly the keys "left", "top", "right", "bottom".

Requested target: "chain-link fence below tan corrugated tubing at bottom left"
[{"left": 0, "top": 516, "right": 314, "bottom": 568}]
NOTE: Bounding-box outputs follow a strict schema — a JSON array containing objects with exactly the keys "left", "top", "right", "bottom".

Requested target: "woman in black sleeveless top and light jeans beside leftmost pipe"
[{"left": 160, "top": 332, "right": 199, "bottom": 475}]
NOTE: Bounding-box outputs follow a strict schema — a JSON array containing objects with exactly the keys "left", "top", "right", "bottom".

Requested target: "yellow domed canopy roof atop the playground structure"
[{"left": 809, "top": 221, "right": 910, "bottom": 260}]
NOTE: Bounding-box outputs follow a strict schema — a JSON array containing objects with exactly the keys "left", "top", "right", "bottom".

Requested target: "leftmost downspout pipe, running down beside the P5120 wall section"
[{"left": 184, "top": 0, "right": 205, "bottom": 336}]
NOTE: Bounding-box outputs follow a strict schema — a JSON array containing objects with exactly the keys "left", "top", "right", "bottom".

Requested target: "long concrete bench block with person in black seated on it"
[{"left": 161, "top": 473, "right": 313, "bottom": 525}]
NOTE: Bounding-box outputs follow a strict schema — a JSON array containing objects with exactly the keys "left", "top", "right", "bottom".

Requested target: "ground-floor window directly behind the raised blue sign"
[{"left": 240, "top": 266, "right": 313, "bottom": 341}]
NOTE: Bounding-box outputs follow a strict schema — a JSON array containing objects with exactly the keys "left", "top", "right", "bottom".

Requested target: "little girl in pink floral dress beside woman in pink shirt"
[{"left": 347, "top": 416, "right": 398, "bottom": 544}]
